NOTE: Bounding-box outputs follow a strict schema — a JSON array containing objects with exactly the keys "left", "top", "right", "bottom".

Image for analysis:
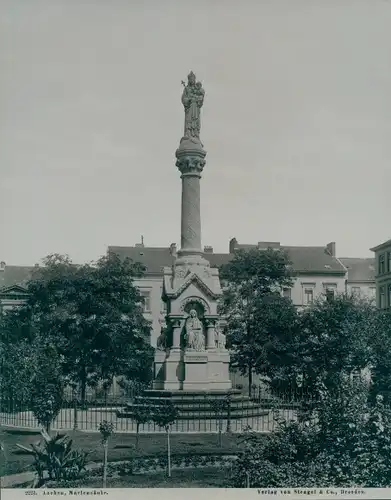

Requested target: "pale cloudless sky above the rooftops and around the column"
[{"left": 0, "top": 0, "right": 391, "bottom": 265}]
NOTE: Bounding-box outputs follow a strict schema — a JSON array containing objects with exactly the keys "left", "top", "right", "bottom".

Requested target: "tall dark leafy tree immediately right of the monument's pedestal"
[{"left": 220, "top": 248, "right": 297, "bottom": 391}]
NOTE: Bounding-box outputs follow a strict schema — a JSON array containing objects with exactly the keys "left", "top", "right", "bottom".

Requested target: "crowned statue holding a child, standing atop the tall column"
[{"left": 182, "top": 71, "right": 205, "bottom": 142}]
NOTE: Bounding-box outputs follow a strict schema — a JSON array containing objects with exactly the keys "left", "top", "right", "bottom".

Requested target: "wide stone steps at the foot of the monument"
[{"left": 118, "top": 389, "right": 269, "bottom": 420}]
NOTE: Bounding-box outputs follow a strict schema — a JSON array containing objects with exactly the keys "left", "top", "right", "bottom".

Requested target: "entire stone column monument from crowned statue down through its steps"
[{"left": 117, "top": 72, "right": 268, "bottom": 429}]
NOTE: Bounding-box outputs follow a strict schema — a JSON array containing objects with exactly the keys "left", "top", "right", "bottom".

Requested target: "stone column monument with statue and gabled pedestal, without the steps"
[{"left": 154, "top": 72, "right": 232, "bottom": 391}]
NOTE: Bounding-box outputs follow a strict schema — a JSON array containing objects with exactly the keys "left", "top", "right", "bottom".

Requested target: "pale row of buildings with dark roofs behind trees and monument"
[{"left": 0, "top": 238, "right": 376, "bottom": 347}]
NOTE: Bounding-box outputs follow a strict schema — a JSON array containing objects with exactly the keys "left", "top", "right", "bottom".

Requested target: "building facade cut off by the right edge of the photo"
[{"left": 371, "top": 240, "right": 391, "bottom": 309}]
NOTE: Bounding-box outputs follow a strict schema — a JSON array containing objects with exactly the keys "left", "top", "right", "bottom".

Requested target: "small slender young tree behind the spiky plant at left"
[{"left": 30, "top": 340, "right": 64, "bottom": 432}]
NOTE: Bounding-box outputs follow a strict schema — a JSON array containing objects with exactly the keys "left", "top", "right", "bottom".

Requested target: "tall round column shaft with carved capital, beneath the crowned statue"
[{"left": 176, "top": 148, "right": 206, "bottom": 256}]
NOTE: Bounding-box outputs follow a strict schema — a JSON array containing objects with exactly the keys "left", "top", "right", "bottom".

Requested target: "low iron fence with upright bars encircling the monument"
[{"left": 0, "top": 386, "right": 311, "bottom": 433}]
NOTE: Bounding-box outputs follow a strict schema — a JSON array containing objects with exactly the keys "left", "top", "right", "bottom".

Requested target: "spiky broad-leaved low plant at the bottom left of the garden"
[{"left": 16, "top": 429, "right": 88, "bottom": 488}]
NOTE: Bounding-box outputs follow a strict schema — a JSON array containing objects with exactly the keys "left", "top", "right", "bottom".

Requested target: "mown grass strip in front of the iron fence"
[{"left": 0, "top": 428, "right": 250, "bottom": 476}]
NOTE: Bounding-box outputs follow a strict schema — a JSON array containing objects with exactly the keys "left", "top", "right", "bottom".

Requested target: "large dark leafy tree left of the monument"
[{"left": 8, "top": 254, "right": 153, "bottom": 402}]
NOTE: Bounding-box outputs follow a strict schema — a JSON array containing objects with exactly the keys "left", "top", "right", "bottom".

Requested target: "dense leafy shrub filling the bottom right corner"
[{"left": 232, "top": 381, "right": 391, "bottom": 488}]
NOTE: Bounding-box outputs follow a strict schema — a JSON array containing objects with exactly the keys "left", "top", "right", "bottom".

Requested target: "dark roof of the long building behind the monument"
[{"left": 109, "top": 245, "right": 346, "bottom": 274}]
